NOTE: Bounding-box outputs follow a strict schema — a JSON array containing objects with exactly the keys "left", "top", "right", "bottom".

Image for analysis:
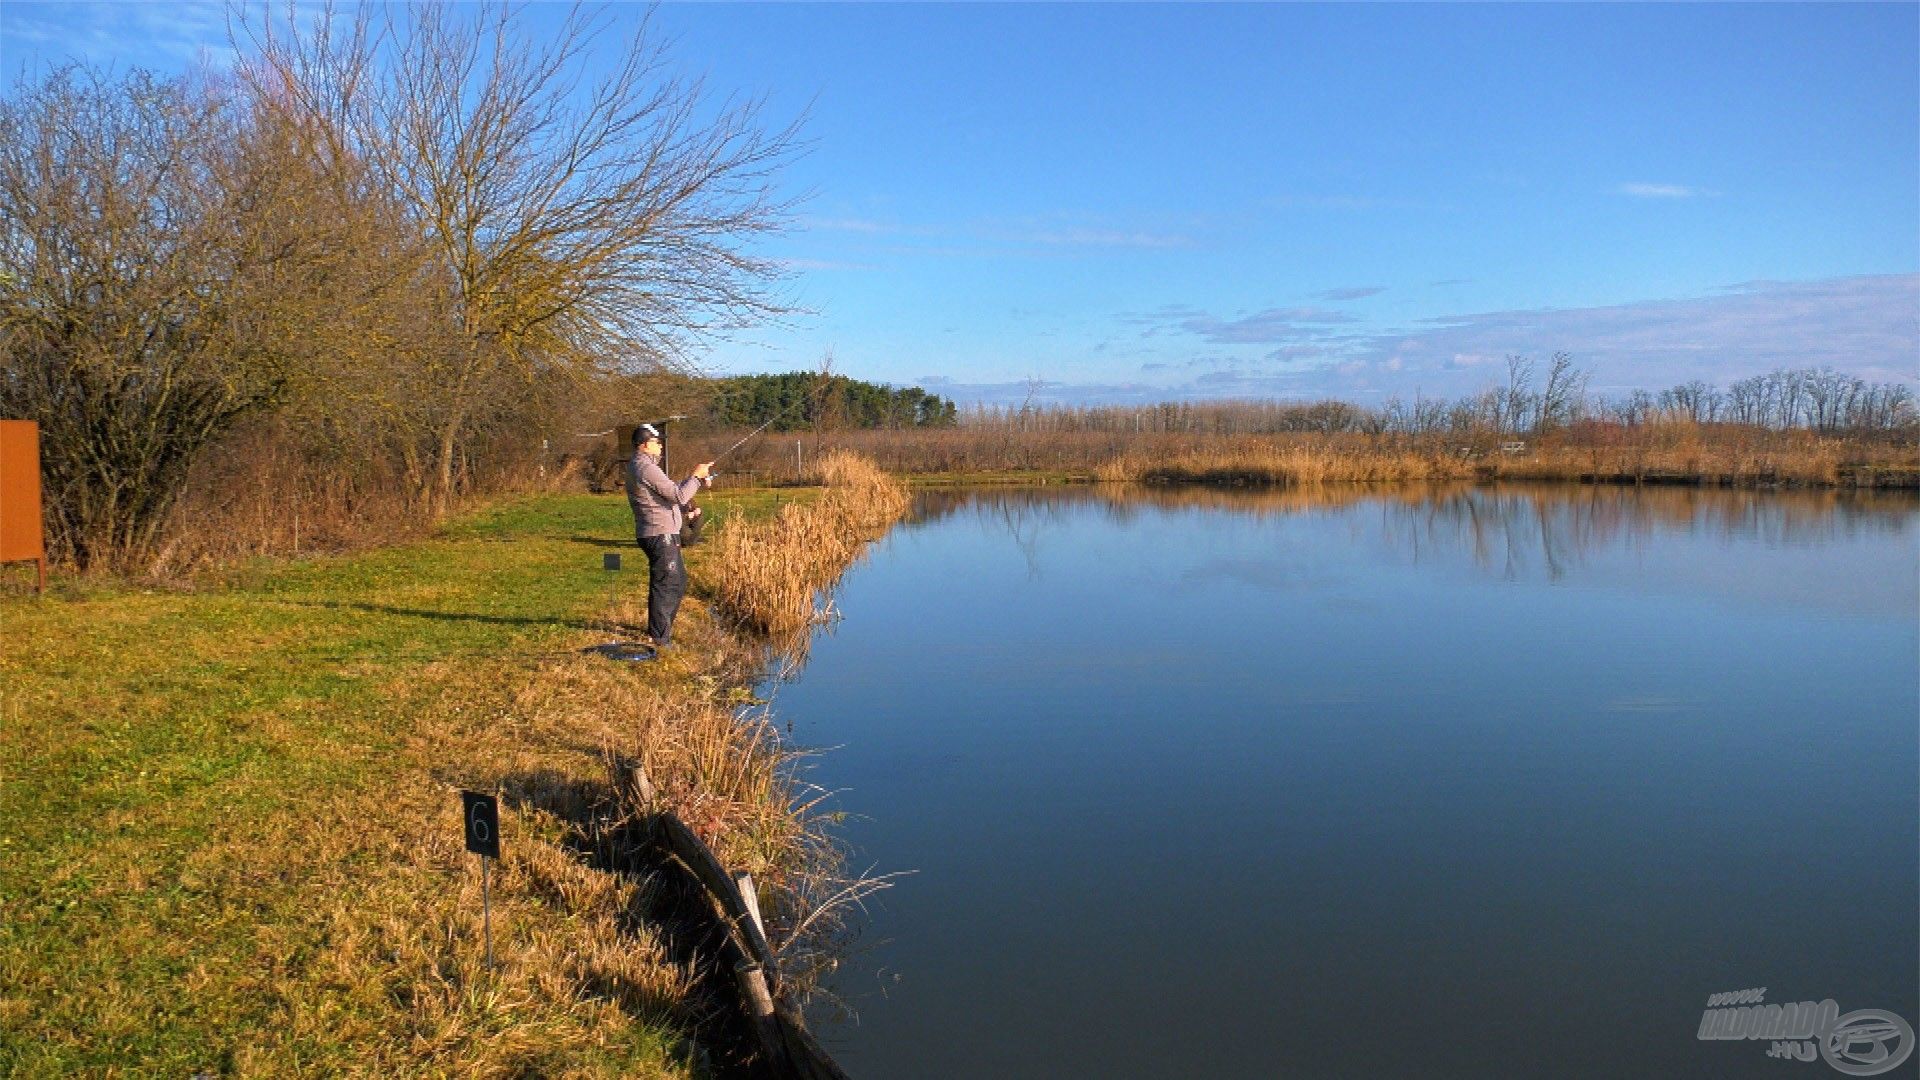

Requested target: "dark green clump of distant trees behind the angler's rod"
[{"left": 708, "top": 371, "right": 958, "bottom": 430}]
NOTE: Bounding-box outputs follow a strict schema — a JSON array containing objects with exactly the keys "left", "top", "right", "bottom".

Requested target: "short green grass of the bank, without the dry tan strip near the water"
[{"left": 0, "top": 492, "right": 793, "bottom": 1076}]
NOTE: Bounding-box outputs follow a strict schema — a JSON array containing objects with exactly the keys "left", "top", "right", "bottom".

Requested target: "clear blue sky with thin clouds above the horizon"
[{"left": 0, "top": 4, "right": 1920, "bottom": 402}]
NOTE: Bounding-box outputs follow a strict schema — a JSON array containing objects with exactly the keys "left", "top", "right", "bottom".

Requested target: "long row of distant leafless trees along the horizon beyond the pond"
[{"left": 960, "top": 354, "right": 1920, "bottom": 436}]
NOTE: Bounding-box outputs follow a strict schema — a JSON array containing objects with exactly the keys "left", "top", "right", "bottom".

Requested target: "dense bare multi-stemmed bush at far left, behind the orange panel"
[{"left": 0, "top": 67, "right": 370, "bottom": 565}]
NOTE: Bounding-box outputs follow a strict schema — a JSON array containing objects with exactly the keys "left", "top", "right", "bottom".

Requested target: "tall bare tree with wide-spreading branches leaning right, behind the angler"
[{"left": 240, "top": 2, "right": 797, "bottom": 502}]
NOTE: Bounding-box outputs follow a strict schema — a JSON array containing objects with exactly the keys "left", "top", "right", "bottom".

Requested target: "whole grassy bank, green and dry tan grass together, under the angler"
[{"left": 0, "top": 466, "right": 906, "bottom": 1076}]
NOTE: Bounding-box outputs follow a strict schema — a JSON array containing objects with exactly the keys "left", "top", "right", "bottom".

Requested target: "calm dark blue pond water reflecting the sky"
[{"left": 776, "top": 488, "right": 1920, "bottom": 1080}]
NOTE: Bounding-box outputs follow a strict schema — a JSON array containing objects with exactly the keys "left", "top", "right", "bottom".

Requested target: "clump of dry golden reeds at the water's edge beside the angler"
[{"left": 703, "top": 452, "right": 908, "bottom": 636}]
